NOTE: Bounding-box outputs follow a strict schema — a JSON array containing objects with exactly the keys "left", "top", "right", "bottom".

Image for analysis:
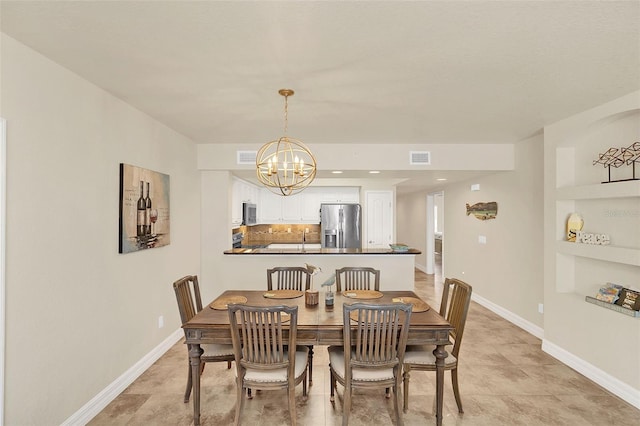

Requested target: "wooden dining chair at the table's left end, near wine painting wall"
[{"left": 173, "top": 275, "right": 234, "bottom": 402}]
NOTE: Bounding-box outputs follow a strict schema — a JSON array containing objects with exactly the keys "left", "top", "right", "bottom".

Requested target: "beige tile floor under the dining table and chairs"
[{"left": 89, "top": 260, "right": 640, "bottom": 426}]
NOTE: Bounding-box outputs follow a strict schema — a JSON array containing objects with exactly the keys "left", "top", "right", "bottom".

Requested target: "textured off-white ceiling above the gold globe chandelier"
[{"left": 0, "top": 1, "right": 640, "bottom": 191}]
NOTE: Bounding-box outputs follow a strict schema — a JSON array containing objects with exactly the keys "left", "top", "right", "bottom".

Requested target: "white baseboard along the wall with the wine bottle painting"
[{"left": 62, "top": 328, "right": 184, "bottom": 426}]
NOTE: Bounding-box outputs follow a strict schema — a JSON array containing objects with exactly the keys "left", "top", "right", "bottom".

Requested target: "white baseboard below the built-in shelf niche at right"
[{"left": 542, "top": 340, "right": 640, "bottom": 409}]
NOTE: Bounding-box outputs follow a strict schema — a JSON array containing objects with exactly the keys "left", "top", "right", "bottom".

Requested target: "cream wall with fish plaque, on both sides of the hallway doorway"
[{"left": 397, "top": 136, "right": 544, "bottom": 328}]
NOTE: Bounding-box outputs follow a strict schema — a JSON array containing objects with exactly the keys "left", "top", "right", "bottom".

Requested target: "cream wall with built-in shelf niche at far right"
[{"left": 543, "top": 91, "right": 640, "bottom": 402}]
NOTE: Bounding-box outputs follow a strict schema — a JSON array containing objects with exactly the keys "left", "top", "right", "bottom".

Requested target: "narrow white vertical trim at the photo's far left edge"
[{"left": 0, "top": 118, "right": 7, "bottom": 425}]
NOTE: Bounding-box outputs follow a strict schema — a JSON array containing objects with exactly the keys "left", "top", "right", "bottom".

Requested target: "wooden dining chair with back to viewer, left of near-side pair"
[{"left": 228, "top": 304, "right": 308, "bottom": 425}]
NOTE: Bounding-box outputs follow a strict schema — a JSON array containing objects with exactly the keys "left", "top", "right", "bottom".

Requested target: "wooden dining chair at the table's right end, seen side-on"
[{"left": 403, "top": 278, "right": 472, "bottom": 413}]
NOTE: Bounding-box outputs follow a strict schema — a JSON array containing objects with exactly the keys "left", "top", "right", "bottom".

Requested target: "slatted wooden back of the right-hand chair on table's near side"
[{"left": 343, "top": 303, "right": 411, "bottom": 368}]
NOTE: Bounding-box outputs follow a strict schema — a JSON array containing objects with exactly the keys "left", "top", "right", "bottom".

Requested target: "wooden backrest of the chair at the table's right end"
[{"left": 440, "top": 278, "right": 472, "bottom": 357}]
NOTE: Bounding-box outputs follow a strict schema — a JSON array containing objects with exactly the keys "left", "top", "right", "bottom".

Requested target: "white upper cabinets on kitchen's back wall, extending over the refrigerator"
[{"left": 258, "top": 187, "right": 360, "bottom": 224}]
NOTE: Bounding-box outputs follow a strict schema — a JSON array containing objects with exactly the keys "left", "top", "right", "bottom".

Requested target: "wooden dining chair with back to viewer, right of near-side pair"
[{"left": 329, "top": 303, "right": 412, "bottom": 426}]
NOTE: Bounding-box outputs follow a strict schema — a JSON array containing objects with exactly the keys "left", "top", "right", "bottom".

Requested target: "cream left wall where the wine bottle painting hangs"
[{"left": 1, "top": 34, "right": 201, "bottom": 425}]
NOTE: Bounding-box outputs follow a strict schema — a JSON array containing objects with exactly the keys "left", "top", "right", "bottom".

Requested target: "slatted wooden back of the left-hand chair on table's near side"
[{"left": 228, "top": 305, "right": 298, "bottom": 370}]
